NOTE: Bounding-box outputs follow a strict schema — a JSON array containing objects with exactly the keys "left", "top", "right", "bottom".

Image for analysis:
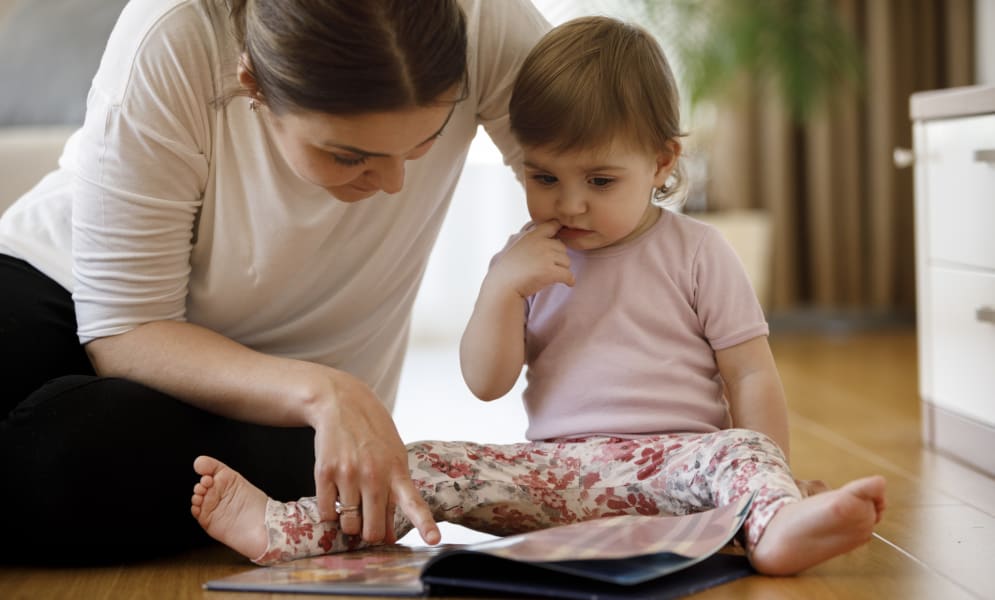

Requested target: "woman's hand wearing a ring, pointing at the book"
[{"left": 312, "top": 371, "right": 441, "bottom": 544}]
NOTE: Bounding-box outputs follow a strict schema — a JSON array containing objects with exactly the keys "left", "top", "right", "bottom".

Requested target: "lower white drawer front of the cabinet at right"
[{"left": 925, "top": 267, "right": 995, "bottom": 425}]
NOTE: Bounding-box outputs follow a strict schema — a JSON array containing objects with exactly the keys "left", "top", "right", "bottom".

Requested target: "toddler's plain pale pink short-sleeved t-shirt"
[{"left": 523, "top": 210, "right": 769, "bottom": 440}]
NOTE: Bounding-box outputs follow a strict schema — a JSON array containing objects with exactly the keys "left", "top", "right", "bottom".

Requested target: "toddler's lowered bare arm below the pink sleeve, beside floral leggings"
[{"left": 715, "top": 336, "right": 790, "bottom": 460}]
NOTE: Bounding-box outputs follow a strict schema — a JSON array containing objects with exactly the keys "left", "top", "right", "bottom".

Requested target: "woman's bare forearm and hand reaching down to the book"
[{"left": 86, "top": 321, "right": 440, "bottom": 543}]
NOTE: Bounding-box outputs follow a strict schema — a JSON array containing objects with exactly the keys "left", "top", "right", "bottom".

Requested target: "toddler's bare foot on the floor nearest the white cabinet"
[{"left": 750, "top": 475, "right": 885, "bottom": 575}]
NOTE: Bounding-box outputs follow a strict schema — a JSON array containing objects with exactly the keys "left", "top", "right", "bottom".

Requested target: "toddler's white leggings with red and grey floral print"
[{"left": 253, "top": 429, "right": 801, "bottom": 565}]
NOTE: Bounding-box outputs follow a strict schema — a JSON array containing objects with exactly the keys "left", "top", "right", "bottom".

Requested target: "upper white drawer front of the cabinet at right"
[{"left": 916, "top": 114, "right": 995, "bottom": 269}]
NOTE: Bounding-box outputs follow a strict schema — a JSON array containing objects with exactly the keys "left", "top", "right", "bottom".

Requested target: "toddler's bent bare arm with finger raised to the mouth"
[{"left": 460, "top": 221, "right": 573, "bottom": 400}]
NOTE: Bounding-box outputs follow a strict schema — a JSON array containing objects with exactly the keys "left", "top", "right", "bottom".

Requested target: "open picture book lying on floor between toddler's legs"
[{"left": 205, "top": 497, "right": 753, "bottom": 600}]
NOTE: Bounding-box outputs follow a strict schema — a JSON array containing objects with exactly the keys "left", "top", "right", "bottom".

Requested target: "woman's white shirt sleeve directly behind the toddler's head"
[{"left": 467, "top": 0, "right": 550, "bottom": 181}]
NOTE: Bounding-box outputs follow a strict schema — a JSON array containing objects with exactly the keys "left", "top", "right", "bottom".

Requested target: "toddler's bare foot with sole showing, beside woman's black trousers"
[{"left": 190, "top": 456, "right": 269, "bottom": 560}]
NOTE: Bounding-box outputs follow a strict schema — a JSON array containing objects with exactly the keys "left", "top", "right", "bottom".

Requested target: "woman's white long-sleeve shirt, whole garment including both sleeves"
[{"left": 0, "top": 0, "right": 549, "bottom": 406}]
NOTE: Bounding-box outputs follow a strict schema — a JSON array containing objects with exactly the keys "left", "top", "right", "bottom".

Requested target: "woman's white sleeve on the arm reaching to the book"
[{"left": 72, "top": 2, "right": 216, "bottom": 344}]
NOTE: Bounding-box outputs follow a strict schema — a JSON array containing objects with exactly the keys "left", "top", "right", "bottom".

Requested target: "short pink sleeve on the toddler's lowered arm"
[{"left": 691, "top": 226, "right": 770, "bottom": 350}]
